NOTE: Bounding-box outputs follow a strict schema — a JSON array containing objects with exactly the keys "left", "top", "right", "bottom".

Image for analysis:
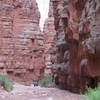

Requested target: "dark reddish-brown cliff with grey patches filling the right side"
[{"left": 50, "top": 0, "right": 100, "bottom": 93}]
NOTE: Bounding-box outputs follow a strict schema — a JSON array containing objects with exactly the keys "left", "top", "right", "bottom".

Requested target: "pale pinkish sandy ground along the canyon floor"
[{"left": 0, "top": 83, "right": 81, "bottom": 100}]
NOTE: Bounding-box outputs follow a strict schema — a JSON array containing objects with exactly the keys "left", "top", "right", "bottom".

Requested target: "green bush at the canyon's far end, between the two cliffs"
[{"left": 39, "top": 75, "right": 52, "bottom": 87}]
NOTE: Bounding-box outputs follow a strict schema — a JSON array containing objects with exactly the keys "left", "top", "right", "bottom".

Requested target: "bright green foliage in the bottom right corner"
[{"left": 83, "top": 86, "right": 100, "bottom": 100}]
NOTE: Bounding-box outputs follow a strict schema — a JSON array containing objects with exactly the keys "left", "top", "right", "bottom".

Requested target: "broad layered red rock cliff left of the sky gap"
[{"left": 0, "top": 0, "right": 44, "bottom": 81}]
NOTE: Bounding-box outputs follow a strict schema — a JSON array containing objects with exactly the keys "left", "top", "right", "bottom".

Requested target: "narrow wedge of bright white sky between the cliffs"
[{"left": 36, "top": 0, "right": 49, "bottom": 30}]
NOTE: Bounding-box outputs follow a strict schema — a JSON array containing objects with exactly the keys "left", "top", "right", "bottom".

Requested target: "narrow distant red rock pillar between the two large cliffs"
[{"left": 43, "top": 3, "right": 56, "bottom": 74}]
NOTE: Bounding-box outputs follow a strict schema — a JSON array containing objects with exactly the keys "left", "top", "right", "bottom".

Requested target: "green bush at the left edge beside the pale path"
[{"left": 0, "top": 75, "right": 13, "bottom": 92}]
